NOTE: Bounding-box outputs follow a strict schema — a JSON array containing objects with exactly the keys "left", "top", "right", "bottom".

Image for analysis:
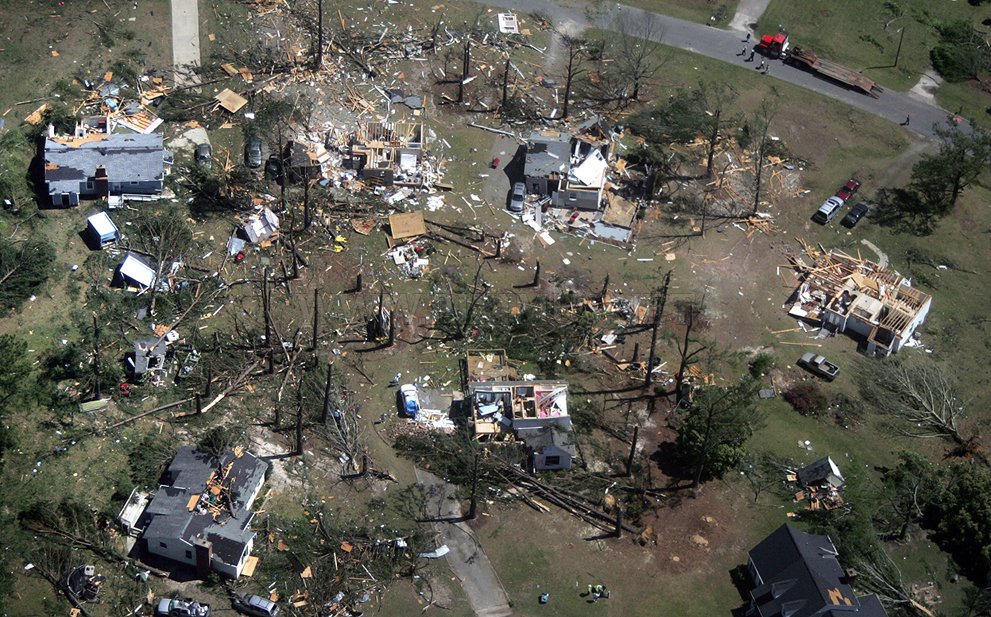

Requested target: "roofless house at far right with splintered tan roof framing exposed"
[{"left": 789, "top": 250, "right": 932, "bottom": 356}]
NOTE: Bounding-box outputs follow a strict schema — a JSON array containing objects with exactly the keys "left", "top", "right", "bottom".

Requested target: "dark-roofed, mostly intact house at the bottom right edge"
[{"left": 746, "top": 524, "right": 887, "bottom": 617}]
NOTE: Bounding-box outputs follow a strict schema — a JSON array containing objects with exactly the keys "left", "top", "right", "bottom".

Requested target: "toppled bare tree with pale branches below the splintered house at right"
[{"left": 859, "top": 360, "right": 969, "bottom": 446}]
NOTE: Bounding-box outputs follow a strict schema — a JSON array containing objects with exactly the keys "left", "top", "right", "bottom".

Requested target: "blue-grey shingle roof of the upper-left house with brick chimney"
[{"left": 45, "top": 133, "right": 170, "bottom": 194}]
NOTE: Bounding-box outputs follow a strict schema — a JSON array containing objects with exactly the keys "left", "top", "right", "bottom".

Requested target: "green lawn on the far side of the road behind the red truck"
[{"left": 759, "top": 0, "right": 991, "bottom": 90}]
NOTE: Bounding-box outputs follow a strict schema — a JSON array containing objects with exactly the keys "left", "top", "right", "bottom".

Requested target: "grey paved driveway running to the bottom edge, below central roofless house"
[{"left": 415, "top": 469, "right": 513, "bottom": 617}]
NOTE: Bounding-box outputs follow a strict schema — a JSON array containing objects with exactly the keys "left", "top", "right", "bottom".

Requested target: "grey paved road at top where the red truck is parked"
[{"left": 481, "top": 0, "right": 964, "bottom": 137}]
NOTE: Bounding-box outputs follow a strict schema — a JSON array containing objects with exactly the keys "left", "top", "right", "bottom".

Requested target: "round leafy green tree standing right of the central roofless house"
[{"left": 678, "top": 377, "right": 761, "bottom": 487}]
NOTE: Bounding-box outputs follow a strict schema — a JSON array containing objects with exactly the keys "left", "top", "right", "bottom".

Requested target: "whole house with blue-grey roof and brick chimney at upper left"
[{"left": 44, "top": 133, "right": 172, "bottom": 207}]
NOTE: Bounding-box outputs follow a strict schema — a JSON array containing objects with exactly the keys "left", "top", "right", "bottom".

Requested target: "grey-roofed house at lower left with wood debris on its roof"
[{"left": 141, "top": 446, "right": 268, "bottom": 578}]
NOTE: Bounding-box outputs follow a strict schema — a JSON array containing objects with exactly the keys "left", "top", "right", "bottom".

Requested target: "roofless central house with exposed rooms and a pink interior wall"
[{"left": 463, "top": 350, "right": 577, "bottom": 471}]
